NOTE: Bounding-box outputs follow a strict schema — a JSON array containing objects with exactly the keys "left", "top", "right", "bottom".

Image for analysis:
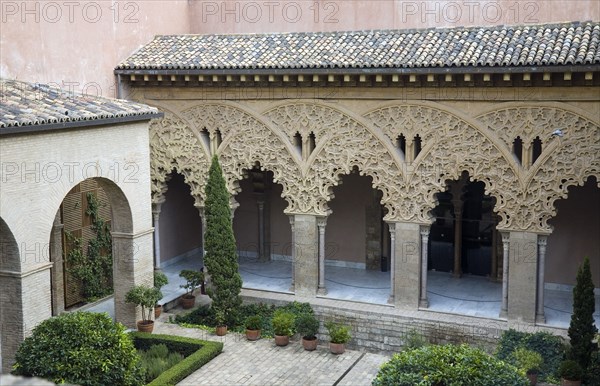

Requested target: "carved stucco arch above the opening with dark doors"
[{"left": 363, "top": 102, "right": 519, "bottom": 228}]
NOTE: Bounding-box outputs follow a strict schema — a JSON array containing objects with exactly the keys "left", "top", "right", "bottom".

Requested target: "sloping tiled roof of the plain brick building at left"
[{"left": 0, "top": 79, "right": 161, "bottom": 133}]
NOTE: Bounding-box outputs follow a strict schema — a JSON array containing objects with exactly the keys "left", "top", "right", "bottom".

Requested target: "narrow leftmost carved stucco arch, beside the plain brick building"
[{"left": 150, "top": 107, "right": 210, "bottom": 206}]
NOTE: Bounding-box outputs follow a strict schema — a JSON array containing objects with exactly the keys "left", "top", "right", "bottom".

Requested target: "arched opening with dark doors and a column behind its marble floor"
[{"left": 427, "top": 172, "right": 502, "bottom": 317}]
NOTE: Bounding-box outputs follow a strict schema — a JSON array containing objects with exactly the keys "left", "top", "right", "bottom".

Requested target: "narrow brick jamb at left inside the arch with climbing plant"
[{"left": 50, "top": 211, "right": 65, "bottom": 316}]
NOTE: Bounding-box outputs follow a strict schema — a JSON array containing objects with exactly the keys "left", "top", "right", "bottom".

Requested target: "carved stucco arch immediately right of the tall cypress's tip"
[{"left": 182, "top": 103, "right": 303, "bottom": 213}]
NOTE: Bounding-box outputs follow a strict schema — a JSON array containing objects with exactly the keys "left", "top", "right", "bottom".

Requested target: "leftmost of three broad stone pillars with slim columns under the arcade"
[{"left": 294, "top": 214, "right": 319, "bottom": 297}]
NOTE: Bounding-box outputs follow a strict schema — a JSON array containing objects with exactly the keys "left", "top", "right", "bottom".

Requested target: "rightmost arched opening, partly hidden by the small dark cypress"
[{"left": 543, "top": 177, "right": 600, "bottom": 328}]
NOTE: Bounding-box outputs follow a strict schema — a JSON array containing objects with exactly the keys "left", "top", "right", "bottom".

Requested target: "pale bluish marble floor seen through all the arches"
[{"left": 87, "top": 256, "right": 600, "bottom": 328}]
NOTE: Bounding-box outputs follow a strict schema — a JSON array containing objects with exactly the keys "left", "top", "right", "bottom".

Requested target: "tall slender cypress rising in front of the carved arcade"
[{"left": 204, "top": 155, "right": 242, "bottom": 322}]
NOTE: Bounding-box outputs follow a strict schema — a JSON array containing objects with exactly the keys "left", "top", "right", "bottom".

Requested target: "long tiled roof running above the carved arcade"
[{"left": 116, "top": 22, "right": 600, "bottom": 72}]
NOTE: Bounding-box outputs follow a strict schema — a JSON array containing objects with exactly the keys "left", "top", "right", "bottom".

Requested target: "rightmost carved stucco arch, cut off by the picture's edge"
[{"left": 479, "top": 103, "right": 600, "bottom": 233}]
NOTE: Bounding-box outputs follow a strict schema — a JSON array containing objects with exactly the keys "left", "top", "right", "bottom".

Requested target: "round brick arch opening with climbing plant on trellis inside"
[{"left": 50, "top": 179, "right": 114, "bottom": 317}]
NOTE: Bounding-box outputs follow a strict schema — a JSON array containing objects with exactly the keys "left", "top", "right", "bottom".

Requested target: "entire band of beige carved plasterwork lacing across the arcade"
[{"left": 151, "top": 102, "right": 600, "bottom": 232}]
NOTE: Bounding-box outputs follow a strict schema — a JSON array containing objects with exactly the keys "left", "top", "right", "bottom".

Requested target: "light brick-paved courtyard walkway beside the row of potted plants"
[{"left": 154, "top": 315, "right": 389, "bottom": 386}]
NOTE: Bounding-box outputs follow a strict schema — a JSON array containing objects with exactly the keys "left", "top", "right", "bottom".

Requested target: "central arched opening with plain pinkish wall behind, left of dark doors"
[{"left": 322, "top": 169, "right": 391, "bottom": 304}]
